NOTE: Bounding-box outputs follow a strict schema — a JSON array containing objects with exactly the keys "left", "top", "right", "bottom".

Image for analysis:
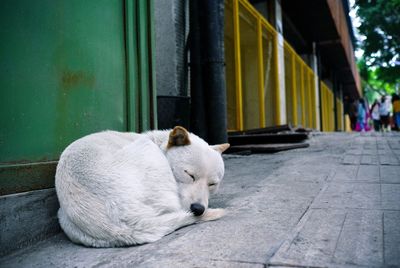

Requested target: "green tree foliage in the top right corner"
[{"left": 355, "top": 0, "right": 400, "bottom": 85}]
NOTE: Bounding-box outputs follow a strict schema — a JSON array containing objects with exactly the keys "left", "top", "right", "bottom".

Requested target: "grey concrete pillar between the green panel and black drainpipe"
[{"left": 154, "top": 0, "right": 190, "bottom": 129}]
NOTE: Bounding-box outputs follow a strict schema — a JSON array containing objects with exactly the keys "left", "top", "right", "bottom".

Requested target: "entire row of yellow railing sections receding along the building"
[{"left": 225, "top": 0, "right": 343, "bottom": 131}]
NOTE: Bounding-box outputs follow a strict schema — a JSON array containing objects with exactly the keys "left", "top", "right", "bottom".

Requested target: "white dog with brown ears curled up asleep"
[{"left": 55, "top": 127, "right": 229, "bottom": 247}]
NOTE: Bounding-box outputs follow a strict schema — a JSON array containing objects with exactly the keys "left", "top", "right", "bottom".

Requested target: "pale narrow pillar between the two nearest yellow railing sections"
[{"left": 274, "top": 0, "right": 287, "bottom": 124}]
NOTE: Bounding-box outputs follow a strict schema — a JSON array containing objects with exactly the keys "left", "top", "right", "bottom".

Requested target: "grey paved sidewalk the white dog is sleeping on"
[{"left": 0, "top": 133, "right": 400, "bottom": 267}]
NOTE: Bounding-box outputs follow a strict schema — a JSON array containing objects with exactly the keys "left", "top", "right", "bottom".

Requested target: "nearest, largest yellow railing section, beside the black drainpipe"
[{"left": 225, "top": 0, "right": 281, "bottom": 130}]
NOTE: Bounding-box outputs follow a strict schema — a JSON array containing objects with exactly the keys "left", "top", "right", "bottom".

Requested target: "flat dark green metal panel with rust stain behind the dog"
[{"left": 0, "top": 0, "right": 127, "bottom": 163}]
